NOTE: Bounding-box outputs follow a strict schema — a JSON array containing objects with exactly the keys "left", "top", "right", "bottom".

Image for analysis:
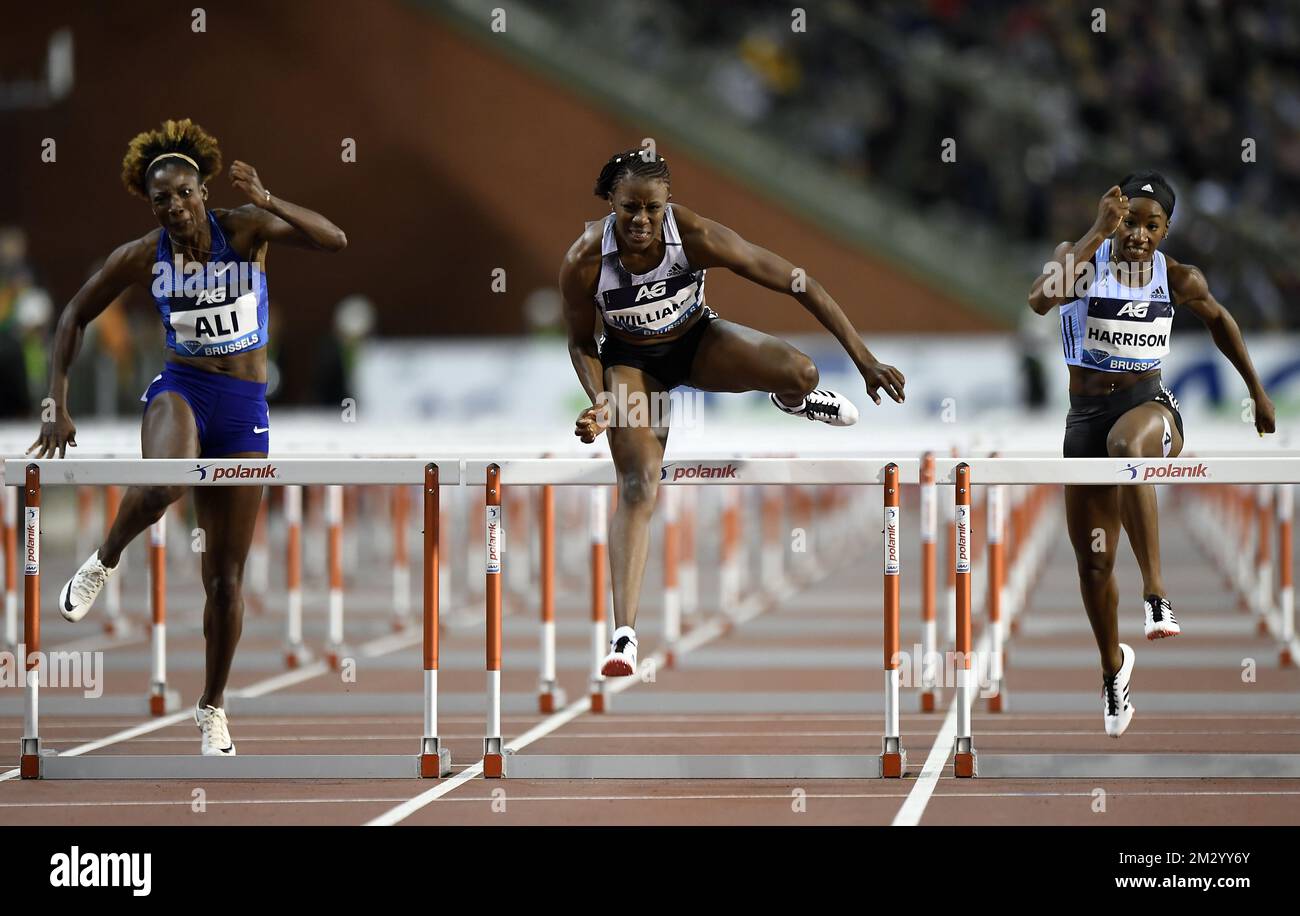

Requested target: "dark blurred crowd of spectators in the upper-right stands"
[{"left": 530, "top": 0, "right": 1300, "bottom": 327}]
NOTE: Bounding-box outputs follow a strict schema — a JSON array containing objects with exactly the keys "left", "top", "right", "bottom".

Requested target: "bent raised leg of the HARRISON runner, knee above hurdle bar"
[{"left": 1106, "top": 401, "right": 1183, "bottom": 598}]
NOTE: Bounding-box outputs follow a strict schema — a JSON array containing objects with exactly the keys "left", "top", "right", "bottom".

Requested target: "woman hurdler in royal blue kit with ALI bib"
[{"left": 29, "top": 120, "right": 347, "bottom": 756}]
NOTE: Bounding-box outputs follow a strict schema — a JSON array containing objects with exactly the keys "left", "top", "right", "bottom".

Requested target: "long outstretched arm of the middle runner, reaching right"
[{"left": 673, "top": 205, "right": 906, "bottom": 404}]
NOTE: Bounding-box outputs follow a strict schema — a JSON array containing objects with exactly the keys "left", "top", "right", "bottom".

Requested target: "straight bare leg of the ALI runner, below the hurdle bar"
[{"left": 194, "top": 452, "right": 267, "bottom": 708}]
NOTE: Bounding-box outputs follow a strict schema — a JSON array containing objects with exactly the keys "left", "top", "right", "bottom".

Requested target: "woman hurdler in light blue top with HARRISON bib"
[{"left": 1030, "top": 172, "right": 1274, "bottom": 738}]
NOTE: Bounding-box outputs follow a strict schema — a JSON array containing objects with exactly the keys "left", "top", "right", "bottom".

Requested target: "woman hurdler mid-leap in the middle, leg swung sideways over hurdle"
[{"left": 560, "top": 149, "right": 904, "bottom": 677}]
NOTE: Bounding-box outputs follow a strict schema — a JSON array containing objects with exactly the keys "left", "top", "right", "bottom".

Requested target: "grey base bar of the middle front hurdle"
[{"left": 484, "top": 748, "right": 881, "bottom": 780}]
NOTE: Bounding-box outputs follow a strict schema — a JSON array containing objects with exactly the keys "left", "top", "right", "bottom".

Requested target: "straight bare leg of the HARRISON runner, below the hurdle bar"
[{"left": 1065, "top": 486, "right": 1123, "bottom": 676}]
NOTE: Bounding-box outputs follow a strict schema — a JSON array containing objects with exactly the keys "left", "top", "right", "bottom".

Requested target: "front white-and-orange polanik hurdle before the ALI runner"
[{"left": 4, "top": 459, "right": 460, "bottom": 780}]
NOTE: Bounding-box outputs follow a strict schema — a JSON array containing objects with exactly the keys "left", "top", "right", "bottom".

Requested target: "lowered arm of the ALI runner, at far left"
[{"left": 27, "top": 236, "right": 153, "bottom": 459}]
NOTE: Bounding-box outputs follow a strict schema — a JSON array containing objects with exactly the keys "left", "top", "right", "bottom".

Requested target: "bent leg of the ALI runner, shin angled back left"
[{"left": 99, "top": 391, "right": 199, "bottom": 568}]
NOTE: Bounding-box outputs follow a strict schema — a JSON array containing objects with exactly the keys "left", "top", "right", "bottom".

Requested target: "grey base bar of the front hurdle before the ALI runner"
[{"left": 36, "top": 754, "right": 420, "bottom": 780}]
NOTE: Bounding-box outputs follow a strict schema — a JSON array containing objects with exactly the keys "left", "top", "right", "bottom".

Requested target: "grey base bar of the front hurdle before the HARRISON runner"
[{"left": 979, "top": 754, "right": 1300, "bottom": 780}]
